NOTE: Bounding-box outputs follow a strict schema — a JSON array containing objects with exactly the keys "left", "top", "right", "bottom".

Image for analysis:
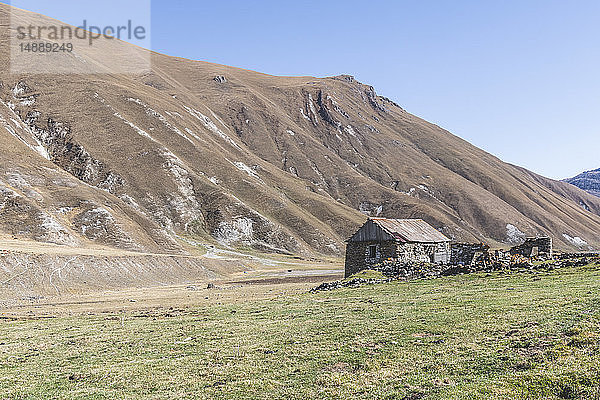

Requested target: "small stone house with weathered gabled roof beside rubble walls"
[{"left": 345, "top": 218, "right": 451, "bottom": 277}]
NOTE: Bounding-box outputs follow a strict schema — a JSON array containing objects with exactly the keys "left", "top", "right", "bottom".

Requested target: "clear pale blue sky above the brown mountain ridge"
[{"left": 5, "top": 0, "right": 600, "bottom": 178}]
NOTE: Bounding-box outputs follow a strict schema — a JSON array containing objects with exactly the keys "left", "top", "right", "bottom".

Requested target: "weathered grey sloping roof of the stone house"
[{"left": 371, "top": 218, "right": 451, "bottom": 243}]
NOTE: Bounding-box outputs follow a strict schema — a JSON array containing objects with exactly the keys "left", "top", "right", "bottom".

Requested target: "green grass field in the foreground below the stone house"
[{"left": 0, "top": 266, "right": 600, "bottom": 400}]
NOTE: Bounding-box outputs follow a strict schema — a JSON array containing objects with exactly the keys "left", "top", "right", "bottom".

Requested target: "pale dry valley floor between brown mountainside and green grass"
[{"left": 0, "top": 238, "right": 343, "bottom": 308}]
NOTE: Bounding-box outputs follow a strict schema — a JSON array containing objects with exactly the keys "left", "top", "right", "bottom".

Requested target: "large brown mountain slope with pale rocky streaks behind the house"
[{"left": 0, "top": 5, "right": 600, "bottom": 255}]
